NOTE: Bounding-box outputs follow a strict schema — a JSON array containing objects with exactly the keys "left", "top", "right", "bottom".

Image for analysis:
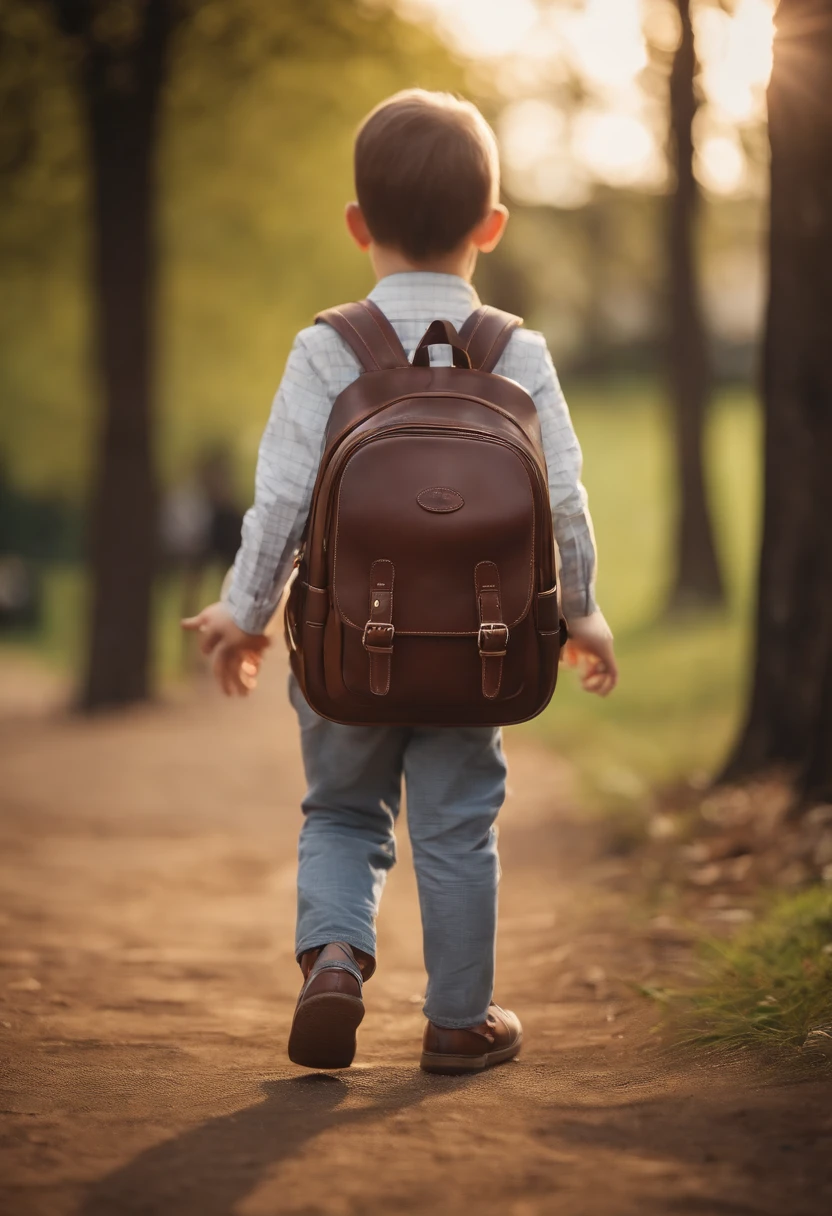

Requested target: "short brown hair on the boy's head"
[{"left": 355, "top": 89, "right": 500, "bottom": 263}]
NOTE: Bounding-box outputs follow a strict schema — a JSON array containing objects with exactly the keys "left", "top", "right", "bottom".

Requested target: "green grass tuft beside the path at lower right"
[{"left": 669, "top": 886, "right": 832, "bottom": 1049}]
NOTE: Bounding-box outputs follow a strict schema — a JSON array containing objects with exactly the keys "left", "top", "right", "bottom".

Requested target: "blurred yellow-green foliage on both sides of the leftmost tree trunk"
[{"left": 0, "top": 0, "right": 462, "bottom": 501}]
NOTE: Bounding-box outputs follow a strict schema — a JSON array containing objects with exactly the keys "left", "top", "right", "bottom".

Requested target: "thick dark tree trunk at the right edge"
[{"left": 723, "top": 0, "right": 832, "bottom": 803}]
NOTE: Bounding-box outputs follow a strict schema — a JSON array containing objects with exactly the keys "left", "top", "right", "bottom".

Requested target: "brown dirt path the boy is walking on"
[{"left": 0, "top": 663, "right": 832, "bottom": 1216}]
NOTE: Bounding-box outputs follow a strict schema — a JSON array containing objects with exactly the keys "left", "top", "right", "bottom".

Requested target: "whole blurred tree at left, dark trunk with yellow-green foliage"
[{"left": 0, "top": 0, "right": 462, "bottom": 706}]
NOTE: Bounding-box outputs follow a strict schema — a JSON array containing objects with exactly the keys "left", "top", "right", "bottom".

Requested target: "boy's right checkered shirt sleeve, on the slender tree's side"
[{"left": 532, "top": 345, "right": 597, "bottom": 620}]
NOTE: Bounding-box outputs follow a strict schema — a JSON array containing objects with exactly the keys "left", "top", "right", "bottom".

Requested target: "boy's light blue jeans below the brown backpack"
[{"left": 289, "top": 677, "right": 506, "bottom": 1028}]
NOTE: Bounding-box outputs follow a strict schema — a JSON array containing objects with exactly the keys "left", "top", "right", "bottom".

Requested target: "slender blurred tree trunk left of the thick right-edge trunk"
[{"left": 668, "top": 0, "right": 724, "bottom": 609}]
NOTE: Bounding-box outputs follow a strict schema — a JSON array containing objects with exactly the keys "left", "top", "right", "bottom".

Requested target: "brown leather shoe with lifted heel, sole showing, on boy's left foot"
[{"left": 288, "top": 941, "right": 364, "bottom": 1068}]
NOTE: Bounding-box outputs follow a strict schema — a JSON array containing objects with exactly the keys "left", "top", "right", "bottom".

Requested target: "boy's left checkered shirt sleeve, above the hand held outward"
[{"left": 225, "top": 334, "right": 332, "bottom": 634}]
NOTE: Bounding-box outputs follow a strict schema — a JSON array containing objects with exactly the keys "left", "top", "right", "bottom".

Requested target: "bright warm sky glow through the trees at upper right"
[{"left": 399, "top": 0, "right": 775, "bottom": 199}]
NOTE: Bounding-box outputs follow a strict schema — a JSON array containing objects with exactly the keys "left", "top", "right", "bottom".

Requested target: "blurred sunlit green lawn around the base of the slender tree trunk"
[{"left": 524, "top": 383, "right": 760, "bottom": 804}]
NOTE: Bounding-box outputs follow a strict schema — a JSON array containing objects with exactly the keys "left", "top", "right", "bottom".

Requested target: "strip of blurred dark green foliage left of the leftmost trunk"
[{"left": 0, "top": 0, "right": 91, "bottom": 497}]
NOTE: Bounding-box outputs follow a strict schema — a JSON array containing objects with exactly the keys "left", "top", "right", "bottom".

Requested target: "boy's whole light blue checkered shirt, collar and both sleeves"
[{"left": 226, "top": 271, "right": 595, "bottom": 634}]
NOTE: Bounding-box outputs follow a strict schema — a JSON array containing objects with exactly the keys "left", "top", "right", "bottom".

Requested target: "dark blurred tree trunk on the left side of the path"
[{"left": 71, "top": 0, "right": 173, "bottom": 710}]
